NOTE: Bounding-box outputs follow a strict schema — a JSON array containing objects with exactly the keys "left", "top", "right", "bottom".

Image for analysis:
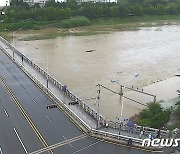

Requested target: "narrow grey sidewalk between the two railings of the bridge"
[{"left": 0, "top": 41, "right": 155, "bottom": 141}]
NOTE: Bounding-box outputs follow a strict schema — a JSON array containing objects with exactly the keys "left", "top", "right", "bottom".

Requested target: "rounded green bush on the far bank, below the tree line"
[{"left": 59, "top": 17, "right": 90, "bottom": 28}]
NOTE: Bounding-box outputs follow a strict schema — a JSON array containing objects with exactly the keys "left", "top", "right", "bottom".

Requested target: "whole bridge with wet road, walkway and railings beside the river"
[{"left": 0, "top": 37, "right": 174, "bottom": 154}]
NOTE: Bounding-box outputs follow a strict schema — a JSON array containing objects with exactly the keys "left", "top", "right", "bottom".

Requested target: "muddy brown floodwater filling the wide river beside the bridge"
[{"left": 10, "top": 25, "right": 180, "bottom": 120}]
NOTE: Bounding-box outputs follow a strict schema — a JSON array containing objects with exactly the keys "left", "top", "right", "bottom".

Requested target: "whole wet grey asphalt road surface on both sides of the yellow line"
[{"left": 0, "top": 48, "right": 156, "bottom": 154}]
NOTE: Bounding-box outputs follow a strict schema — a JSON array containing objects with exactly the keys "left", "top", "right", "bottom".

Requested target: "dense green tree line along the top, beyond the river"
[{"left": 3, "top": 0, "right": 180, "bottom": 23}]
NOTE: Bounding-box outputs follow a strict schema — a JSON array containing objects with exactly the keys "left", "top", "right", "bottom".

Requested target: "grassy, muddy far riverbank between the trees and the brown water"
[{"left": 0, "top": 15, "right": 180, "bottom": 41}]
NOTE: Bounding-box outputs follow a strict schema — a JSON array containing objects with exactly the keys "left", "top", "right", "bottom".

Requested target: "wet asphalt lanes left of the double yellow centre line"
[{"left": 0, "top": 81, "right": 43, "bottom": 154}]
